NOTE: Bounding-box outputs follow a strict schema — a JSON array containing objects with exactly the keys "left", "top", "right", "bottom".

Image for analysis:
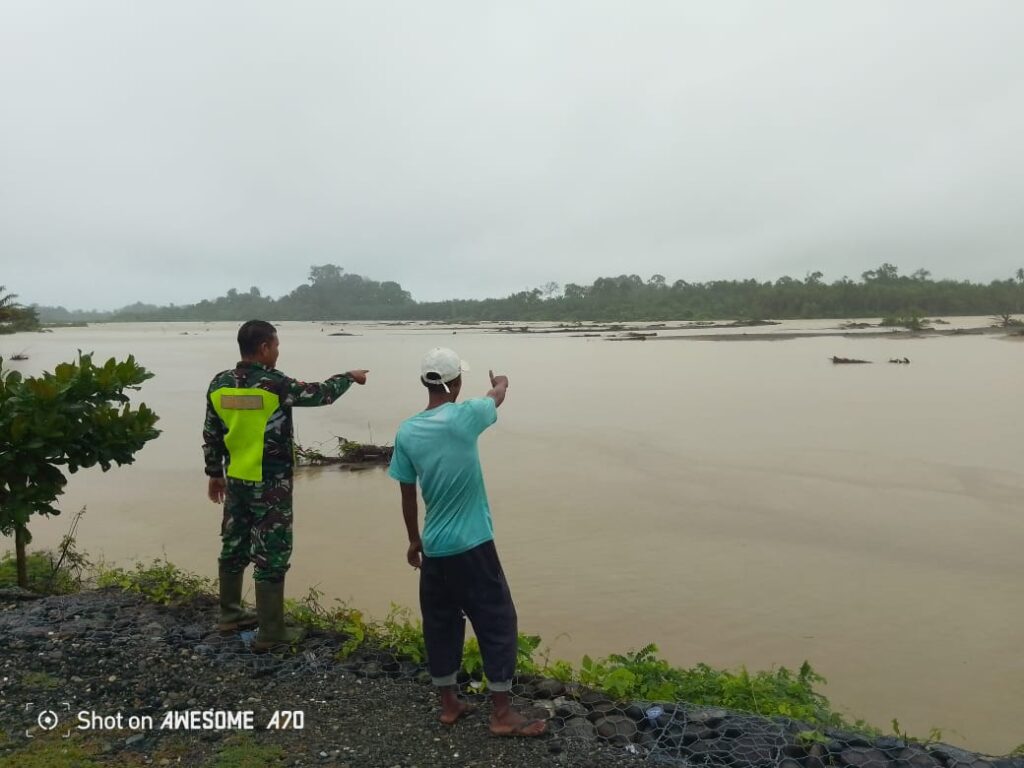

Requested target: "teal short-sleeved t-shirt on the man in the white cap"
[{"left": 388, "top": 397, "right": 498, "bottom": 557}]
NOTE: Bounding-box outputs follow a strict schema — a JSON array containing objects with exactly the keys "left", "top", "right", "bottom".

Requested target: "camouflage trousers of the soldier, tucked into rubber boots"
[{"left": 220, "top": 477, "right": 292, "bottom": 582}]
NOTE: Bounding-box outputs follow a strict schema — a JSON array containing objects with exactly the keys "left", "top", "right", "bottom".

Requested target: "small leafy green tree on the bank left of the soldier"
[{"left": 0, "top": 352, "right": 160, "bottom": 587}]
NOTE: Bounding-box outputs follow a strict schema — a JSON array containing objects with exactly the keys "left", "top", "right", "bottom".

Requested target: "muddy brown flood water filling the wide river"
[{"left": 0, "top": 318, "right": 1024, "bottom": 754}]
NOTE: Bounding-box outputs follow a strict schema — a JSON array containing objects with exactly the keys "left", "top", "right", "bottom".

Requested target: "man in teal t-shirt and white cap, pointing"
[{"left": 389, "top": 347, "right": 547, "bottom": 736}]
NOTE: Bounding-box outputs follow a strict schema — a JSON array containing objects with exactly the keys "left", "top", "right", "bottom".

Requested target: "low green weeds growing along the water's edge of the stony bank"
[{"left": 8, "top": 552, "right": 880, "bottom": 734}]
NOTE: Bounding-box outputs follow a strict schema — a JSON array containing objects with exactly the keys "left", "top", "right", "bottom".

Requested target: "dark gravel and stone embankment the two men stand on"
[{"left": 0, "top": 590, "right": 1024, "bottom": 768}]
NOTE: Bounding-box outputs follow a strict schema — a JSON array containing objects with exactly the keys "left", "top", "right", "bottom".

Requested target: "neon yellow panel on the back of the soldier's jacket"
[{"left": 210, "top": 387, "right": 280, "bottom": 482}]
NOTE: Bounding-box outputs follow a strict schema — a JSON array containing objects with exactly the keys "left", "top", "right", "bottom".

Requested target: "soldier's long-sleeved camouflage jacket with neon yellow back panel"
[{"left": 203, "top": 361, "right": 352, "bottom": 479}]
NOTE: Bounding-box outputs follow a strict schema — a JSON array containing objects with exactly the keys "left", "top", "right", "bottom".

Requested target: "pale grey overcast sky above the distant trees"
[{"left": 0, "top": 0, "right": 1024, "bottom": 308}]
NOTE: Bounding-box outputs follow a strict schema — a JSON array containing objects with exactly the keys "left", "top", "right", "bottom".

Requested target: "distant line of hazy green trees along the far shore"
[{"left": 28, "top": 263, "right": 1024, "bottom": 323}]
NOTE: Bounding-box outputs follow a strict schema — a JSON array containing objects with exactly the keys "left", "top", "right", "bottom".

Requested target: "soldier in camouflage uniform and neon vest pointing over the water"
[{"left": 203, "top": 321, "right": 368, "bottom": 650}]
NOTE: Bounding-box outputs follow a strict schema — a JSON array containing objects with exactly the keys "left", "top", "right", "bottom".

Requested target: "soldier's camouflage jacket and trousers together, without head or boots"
[{"left": 203, "top": 361, "right": 352, "bottom": 582}]
